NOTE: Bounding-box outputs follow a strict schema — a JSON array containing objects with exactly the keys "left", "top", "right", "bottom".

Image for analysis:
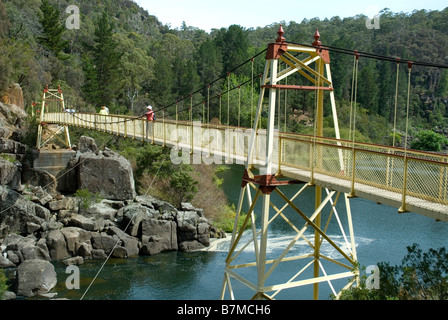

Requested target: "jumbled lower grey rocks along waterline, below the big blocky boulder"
[{"left": 0, "top": 186, "right": 225, "bottom": 297}]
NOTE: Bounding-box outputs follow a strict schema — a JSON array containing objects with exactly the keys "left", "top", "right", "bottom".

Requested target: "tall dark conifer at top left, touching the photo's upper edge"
[{"left": 37, "top": 0, "right": 69, "bottom": 60}]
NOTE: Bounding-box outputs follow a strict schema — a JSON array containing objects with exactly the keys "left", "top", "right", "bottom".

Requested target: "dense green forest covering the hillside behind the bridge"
[{"left": 0, "top": 0, "right": 448, "bottom": 148}]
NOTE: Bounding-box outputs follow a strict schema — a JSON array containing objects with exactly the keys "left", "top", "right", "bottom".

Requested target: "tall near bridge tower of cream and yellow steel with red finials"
[{"left": 221, "top": 27, "right": 359, "bottom": 300}]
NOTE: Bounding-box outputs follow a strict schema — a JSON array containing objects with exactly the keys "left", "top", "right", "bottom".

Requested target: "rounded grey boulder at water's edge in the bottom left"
[{"left": 17, "top": 259, "right": 57, "bottom": 297}]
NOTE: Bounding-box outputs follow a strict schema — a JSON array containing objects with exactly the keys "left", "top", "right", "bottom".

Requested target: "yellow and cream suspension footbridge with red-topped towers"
[{"left": 33, "top": 27, "right": 448, "bottom": 299}]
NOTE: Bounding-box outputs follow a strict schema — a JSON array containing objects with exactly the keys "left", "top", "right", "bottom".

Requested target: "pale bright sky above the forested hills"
[{"left": 134, "top": 0, "right": 448, "bottom": 32}]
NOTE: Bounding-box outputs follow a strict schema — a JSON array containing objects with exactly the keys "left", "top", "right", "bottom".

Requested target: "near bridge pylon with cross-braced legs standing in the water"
[{"left": 221, "top": 27, "right": 358, "bottom": 299}]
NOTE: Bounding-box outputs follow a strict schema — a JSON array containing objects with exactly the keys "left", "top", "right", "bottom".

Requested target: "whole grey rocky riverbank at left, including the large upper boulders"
[{"left": 0, "top": 93, "right": 225, "bottom": 300}]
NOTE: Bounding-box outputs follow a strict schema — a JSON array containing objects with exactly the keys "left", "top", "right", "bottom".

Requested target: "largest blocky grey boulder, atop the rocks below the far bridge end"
[{"left": 78, "top": 151, "right": 136, "bottom": 200}]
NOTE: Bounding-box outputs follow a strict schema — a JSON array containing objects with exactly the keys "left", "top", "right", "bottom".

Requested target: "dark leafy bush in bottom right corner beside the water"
[{"left": 340, "top": 244, "right": 448, "bottom": 300}]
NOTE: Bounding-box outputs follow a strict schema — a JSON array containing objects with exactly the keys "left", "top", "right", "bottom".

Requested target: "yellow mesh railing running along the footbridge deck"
[{"left": 44, "top": 113, "right": 448, "bottom": 214}]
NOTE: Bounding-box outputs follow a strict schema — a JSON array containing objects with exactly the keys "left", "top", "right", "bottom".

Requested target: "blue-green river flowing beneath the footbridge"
[{"left": 47, "top": 165, "right": 448, "bottom": 300}]
